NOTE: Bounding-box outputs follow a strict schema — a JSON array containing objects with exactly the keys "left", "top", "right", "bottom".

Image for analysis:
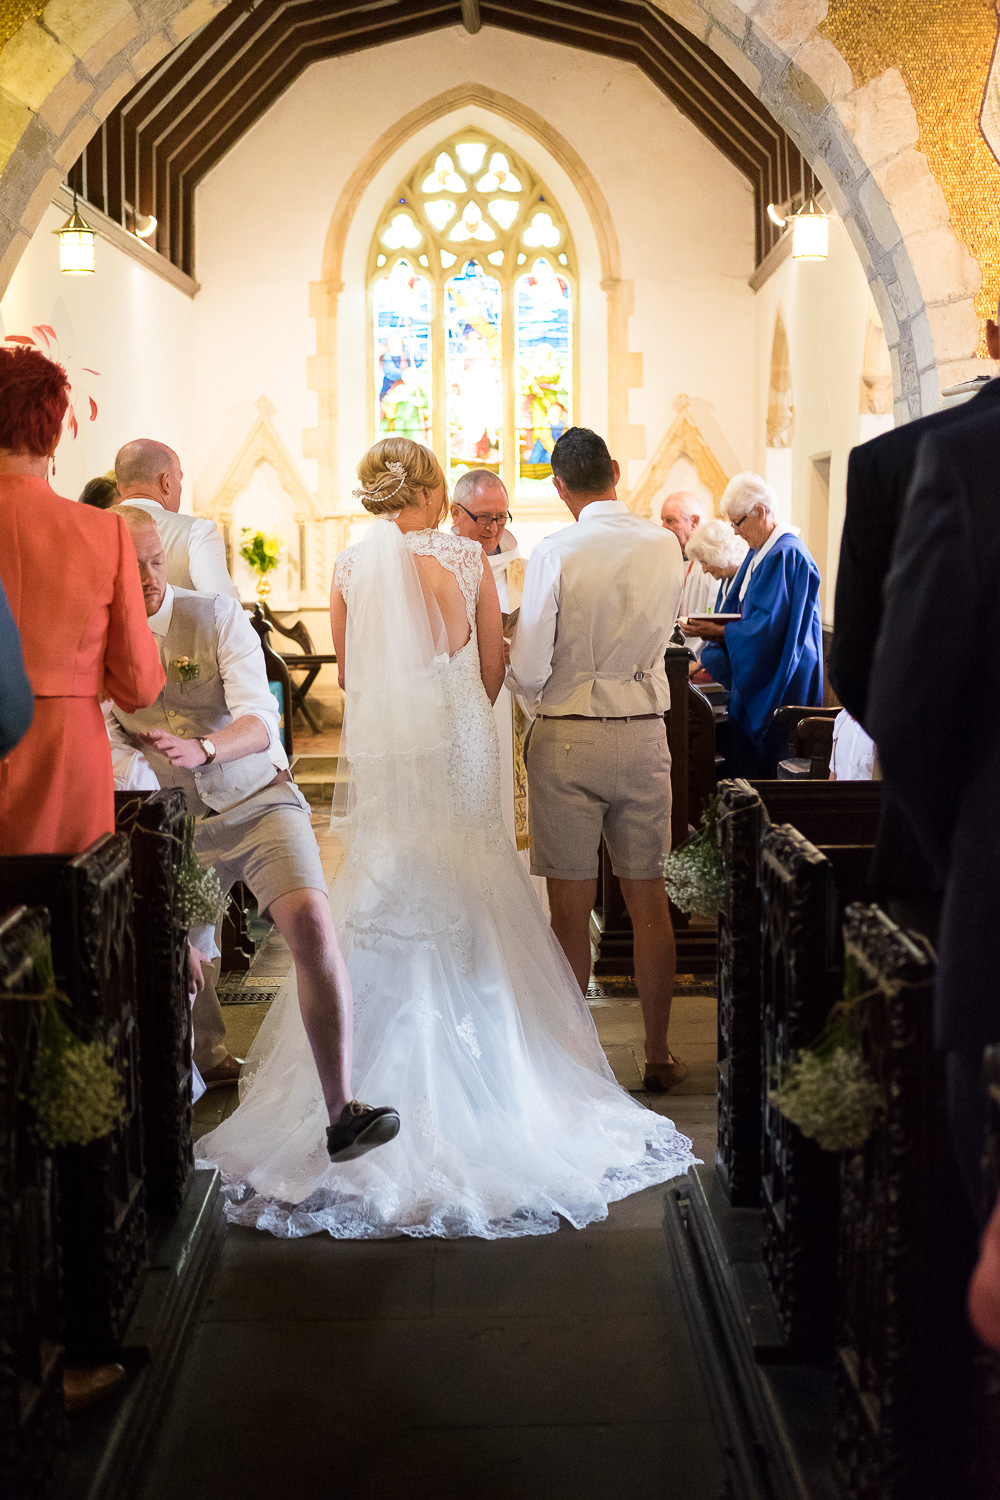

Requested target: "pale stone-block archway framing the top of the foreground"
[{"left": 0, "top": 0, "right": 981, "bottom": 420}]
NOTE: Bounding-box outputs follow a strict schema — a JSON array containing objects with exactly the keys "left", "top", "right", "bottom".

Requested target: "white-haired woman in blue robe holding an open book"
[{"left": 697, "top": 473, "right": 823, "bottom": 777}]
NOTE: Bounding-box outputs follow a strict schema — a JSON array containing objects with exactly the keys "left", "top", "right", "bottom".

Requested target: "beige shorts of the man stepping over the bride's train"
[{"left": 195, "top": 782, "right": 327, "bottom": 915}]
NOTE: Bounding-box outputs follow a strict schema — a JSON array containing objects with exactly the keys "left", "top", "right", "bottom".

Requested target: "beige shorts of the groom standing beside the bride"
[{"left": 528, "top": 719, "right": 670, "bottom": 881}]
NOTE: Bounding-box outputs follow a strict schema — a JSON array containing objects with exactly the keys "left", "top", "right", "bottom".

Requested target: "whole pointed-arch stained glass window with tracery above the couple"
[{"left": 369, "top": 129, "right": 577, "bottom": 500}]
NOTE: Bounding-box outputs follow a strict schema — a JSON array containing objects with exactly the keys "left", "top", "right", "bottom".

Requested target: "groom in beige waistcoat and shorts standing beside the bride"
[{"left": 507, "top": 428, "right": 687, "bottom": 1092}]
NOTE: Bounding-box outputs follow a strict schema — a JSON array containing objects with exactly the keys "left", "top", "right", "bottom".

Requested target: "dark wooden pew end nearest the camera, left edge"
[{"left": 0, "top": 906, "right": 66, "bottom": 1500}]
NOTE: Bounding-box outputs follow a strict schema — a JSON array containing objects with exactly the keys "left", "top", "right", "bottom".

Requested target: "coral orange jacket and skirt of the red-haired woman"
[{"left": 0, "top": 474, "right": 163, "bottom": 855}]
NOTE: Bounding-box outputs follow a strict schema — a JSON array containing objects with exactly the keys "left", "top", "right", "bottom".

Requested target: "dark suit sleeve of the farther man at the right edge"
[{"left": 829, "top": 449, "right": 891, "bottom": 729}]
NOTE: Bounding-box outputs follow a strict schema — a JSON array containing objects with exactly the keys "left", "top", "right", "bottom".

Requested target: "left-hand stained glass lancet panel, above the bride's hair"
[{"left": 373, "top": 261, "right": 433, "bottom": 443}]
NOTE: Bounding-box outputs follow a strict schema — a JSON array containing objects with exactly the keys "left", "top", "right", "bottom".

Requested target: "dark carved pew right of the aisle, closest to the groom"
[{"left": 715, "top": 780, "right": 882, "bottom": 1208}]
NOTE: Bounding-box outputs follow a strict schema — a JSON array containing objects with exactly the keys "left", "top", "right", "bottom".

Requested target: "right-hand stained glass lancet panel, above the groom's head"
[{"left": 514, "top": 260, "right": 573, "bottom": 494}]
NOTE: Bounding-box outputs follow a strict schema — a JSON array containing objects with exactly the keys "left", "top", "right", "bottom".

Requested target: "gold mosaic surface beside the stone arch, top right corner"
[{"left": 820, "top": 0, "right": 1000, "bottom": 356}]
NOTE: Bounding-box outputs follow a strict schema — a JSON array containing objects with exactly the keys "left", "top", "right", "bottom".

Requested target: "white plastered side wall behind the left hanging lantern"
[{"left": 0, "top": 207, "right": 195, "bottom": 510}]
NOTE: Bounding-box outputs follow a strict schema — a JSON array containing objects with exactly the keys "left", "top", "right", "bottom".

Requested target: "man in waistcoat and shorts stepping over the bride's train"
[{"left": 109, "top": 506, "right": 399, "bottom": 1161}]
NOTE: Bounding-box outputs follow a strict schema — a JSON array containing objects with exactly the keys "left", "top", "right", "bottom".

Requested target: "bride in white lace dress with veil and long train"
[{"left": 199, "top": 438, "right": 694, "bottom": 1239}]
